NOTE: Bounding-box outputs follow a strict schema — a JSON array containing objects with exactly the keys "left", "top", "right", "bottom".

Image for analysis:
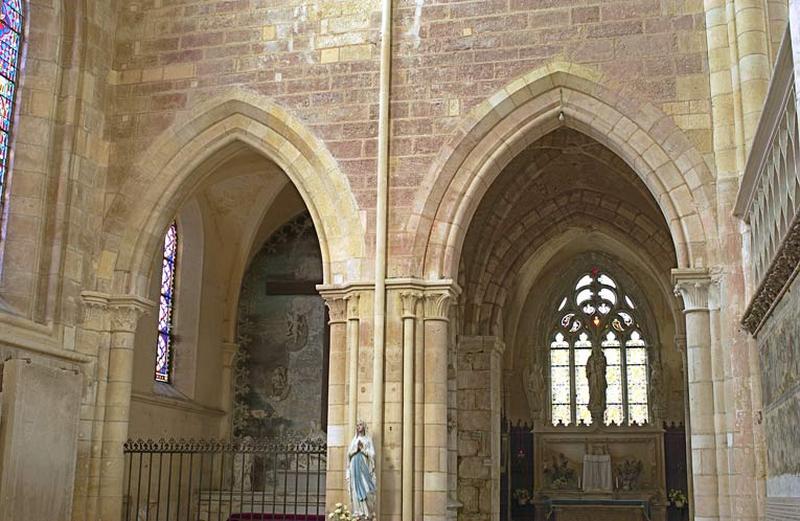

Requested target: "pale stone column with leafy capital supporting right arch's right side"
[{"left": 672, "top": 269, "right": 719, "bottom": 521}]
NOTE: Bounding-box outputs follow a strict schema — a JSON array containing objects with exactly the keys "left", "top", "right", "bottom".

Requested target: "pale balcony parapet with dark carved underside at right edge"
[{"left": 734, "top": 25, "right": 800, "bottom": 333}]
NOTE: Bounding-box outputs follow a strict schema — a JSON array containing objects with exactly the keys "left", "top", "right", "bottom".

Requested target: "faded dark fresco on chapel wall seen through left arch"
[{"left": 234, "top": 213, "right": 327, "bottom": 438}]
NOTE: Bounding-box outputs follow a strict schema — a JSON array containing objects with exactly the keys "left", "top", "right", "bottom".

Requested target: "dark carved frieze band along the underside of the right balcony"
[{"left": 742, "top": 215, "right": 800, "bottom": 336}]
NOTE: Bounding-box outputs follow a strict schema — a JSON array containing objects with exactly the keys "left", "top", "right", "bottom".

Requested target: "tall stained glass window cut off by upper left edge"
[{"left": 0, "top": 0, "right": 22, "bottom": 213}]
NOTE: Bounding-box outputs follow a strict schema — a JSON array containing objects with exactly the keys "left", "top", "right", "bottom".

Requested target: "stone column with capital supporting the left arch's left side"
[{"left": 98, "top": 296, "right": 152, "bottom": 521}]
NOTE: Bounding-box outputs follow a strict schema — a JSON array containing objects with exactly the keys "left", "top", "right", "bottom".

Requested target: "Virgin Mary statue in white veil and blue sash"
[{"left": 345, "top": 421, "right": 377, "bottom": 520}]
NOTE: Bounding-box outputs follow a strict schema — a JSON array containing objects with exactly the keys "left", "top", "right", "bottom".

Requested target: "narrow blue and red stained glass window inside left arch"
[{"left": 155, "top": 221, "right": 178, "bottom": 383}]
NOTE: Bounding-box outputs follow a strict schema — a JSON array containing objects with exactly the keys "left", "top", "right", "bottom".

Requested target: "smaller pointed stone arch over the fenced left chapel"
[{"left": 99, "top": 89, "right": 365, "bottom": 294}]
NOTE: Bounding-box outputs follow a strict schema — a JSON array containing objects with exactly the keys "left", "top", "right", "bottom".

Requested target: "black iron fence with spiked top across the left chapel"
[{"left": 123, "top": 439, "right": 327, "bottom": 521}]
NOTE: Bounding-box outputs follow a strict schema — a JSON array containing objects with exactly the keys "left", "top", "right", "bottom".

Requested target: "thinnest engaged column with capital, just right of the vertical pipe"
[{"left": 400, "top": 291, "right": 422, "bottom": 519}]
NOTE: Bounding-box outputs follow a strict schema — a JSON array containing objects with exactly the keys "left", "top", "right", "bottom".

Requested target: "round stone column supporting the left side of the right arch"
[{"left": 423, "top": 289, "right": 452, "bottom": 521}]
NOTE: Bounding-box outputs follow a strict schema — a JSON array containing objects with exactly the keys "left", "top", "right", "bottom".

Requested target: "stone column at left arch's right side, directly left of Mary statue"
[{"left": 322, "top": 292, "right": 347, "bottom": 512}]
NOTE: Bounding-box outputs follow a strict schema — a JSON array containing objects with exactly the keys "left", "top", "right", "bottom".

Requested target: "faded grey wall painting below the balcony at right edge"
[{"left": 758, "top": 278, "right": 800, "bottom": 495}]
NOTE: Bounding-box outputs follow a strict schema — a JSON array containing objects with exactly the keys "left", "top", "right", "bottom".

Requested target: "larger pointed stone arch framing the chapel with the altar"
[{"left": 408, "top": 62, "right": 714, "bottom": 279}]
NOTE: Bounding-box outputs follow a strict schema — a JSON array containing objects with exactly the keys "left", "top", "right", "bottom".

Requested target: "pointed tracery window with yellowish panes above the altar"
[{"left": 550, "top": 268, "right": 650, "bottom": 425}]
